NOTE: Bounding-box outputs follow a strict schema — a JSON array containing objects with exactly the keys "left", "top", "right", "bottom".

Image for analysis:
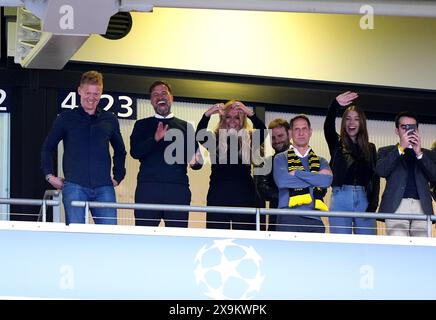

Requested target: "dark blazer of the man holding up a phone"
[{"left": 375, "top": 145, "right": 436, "bottom": 214}]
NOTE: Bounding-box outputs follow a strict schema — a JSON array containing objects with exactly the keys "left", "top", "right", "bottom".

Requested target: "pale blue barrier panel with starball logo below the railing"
[{"left": 0, "top": 222, "right": 436, "bottom": 300}]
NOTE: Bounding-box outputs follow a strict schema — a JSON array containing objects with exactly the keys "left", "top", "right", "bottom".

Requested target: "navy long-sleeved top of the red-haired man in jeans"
[{"left": 41, "top": 107, "right": 126, "bottom": 188}]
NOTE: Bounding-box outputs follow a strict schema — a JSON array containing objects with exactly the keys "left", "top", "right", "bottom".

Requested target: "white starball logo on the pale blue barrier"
[{"left": 194, "top": 239, "right": 264, "bottom": 300}]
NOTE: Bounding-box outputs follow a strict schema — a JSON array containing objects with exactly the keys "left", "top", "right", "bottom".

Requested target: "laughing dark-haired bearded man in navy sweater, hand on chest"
[{"left": 130, "top": 81, "right": 201, "bottom": 228}]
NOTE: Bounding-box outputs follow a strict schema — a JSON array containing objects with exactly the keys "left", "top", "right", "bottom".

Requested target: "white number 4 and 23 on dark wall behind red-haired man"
[{"left": 58, "top": 91, "right": 137, "bottom": 120}]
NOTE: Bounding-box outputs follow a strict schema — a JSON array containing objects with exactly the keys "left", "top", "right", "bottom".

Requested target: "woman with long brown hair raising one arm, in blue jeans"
[{"left": 324, "top": 91, "right": 380, "bottom": 234}]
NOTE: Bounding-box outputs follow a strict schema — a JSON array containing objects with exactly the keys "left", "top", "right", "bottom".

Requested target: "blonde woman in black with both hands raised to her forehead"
[{"left": 196, "top": 100, "right": 266, "bottom": 230}]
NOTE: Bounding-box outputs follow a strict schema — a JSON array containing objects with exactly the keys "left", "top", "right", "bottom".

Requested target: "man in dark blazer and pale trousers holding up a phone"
[{"left": 375, "top": 112, "right": 436, "bottom": 237}]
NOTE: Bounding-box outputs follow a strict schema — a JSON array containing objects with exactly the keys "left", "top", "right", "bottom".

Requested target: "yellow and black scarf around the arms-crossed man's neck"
[{"left": 288, "top": 148, "right": 329, "bottom": 211}]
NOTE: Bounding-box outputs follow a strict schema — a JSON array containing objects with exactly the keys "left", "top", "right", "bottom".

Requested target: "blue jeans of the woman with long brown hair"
[{"left": 329, "top": 185, "right": 377, "bottom": 235}]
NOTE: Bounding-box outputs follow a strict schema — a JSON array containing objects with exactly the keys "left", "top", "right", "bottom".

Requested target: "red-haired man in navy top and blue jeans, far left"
[{"left": 41, "top": 71, "right": 126, "bottom": 224}]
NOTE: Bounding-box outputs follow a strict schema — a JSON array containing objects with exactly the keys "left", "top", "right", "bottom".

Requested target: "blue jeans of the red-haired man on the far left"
[{"left": 62, "top": 181, "right": 117, "bottom": 224}]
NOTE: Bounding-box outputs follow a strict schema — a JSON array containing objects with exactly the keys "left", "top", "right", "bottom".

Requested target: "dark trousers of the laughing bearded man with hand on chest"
[{"left": 135, "top": 182, "right": 191, "bottom": 228}]
